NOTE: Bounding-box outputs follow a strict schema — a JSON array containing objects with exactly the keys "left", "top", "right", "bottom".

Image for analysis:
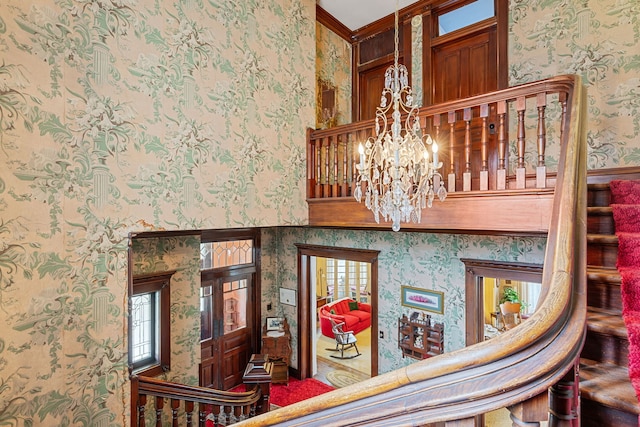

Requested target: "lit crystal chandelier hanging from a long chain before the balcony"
[{"left": 354, "top": 1, "right": 447, "bottom": 231}]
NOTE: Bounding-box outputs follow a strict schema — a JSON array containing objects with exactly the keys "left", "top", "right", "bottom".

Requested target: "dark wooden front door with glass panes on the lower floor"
[{"left": 200, "top": 272, "right": 255, "bottom": 390}]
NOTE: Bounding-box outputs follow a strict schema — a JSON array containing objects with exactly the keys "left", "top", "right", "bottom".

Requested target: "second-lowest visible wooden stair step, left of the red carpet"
[{"left": 580, "top": 307, "right": 629, "bottom": 367}]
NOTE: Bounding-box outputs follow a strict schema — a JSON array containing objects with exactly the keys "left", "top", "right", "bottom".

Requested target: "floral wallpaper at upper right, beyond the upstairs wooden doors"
[{"left": 508, "top": 0, "right": 640, "bottom": 169}]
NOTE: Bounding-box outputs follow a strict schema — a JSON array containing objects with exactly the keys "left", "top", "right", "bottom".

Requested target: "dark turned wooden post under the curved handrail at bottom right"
[{"left": 549, "top": 361, "right": 580, "bottom": 427}]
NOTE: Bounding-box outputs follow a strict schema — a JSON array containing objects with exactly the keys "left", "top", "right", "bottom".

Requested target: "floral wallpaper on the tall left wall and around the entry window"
[{"left": 0, "top": 0, "right": 316, "bottom": 427}]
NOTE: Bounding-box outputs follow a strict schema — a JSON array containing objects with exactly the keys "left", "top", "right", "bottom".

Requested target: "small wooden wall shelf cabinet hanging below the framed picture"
[{"left": 398, "top": 315, "right": 444, "bottom": 359}]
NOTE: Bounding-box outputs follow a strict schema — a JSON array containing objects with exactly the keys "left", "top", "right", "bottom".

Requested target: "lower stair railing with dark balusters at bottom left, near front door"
[{"left": 131, "top": 375, "right": 268, "bottom": 427}]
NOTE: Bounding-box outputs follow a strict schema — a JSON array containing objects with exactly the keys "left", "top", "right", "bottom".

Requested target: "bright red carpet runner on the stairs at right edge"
[{"left": 610, "top": 181, "right": 640, "bottom": 404}]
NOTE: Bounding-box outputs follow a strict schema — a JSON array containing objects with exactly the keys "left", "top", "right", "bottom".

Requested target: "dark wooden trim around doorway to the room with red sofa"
[{"left": 296, "top": 243, "right": 380, "bottom": 379}]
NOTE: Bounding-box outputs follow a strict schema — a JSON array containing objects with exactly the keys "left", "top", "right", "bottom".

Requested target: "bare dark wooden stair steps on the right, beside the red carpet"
[{"left": 580, "top": 184, "right": 640, "bottom": 427}]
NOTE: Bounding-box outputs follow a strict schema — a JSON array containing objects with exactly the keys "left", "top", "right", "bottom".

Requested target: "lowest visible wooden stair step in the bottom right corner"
[{"left": 580, "top": 358, "right": 640, "bottom": 427}]
